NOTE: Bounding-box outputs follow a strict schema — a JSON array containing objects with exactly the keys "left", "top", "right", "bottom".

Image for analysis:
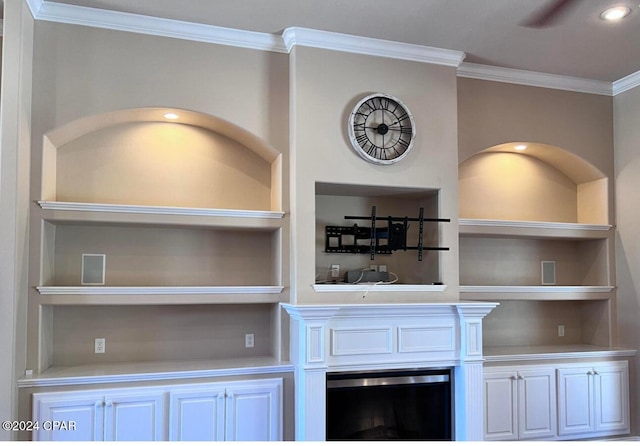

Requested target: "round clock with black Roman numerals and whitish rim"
[{"left": 349, "top": 93, "right": 416, "bottom": 164}]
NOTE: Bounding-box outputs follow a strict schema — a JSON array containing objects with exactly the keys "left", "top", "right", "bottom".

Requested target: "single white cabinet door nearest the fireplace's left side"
[{"left": 225, "top": 379, "right": 282, "bottom": 441}]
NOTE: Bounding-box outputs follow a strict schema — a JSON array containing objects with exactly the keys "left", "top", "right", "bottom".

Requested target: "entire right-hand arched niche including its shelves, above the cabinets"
[{"left": 459, "top": 141, "right": 616, "bottom": 357}]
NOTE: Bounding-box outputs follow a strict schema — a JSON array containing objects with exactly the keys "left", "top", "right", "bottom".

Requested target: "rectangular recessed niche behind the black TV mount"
[{"left": 315, "top": 183, "right": 444, "bottom": 292}]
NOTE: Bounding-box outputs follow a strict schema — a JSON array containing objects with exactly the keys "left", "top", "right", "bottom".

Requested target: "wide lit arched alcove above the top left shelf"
[{"left": 42, "top": 108, "right": 282, "bottom": 210}]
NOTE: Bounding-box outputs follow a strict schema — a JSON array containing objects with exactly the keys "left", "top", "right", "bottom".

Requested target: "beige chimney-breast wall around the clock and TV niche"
[{"left": 290, "top": 47, "right": 458, "bottom": 302}]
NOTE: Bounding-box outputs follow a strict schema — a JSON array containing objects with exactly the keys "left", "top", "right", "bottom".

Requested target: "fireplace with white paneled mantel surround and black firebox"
[{"left": 282, "top": 302, "right": 497, "bottom": 441}]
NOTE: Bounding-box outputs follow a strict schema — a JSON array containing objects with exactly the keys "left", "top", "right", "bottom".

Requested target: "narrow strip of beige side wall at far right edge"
[{"left": 614, "top": 87, "right": 640, "bottom": 434}]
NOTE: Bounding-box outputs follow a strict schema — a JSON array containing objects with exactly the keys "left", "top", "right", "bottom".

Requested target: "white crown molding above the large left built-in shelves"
[{"left": 30, "top": 0, "right": 287, "bottom": 52}]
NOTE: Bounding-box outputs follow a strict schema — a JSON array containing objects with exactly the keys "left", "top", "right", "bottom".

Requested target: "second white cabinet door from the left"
[{"left": 104, "top": 389, "right": 167, "bottom": 441}]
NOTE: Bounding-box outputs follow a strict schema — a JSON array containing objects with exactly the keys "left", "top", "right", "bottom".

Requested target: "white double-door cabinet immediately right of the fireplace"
[{"left": 484, "top": 367, "right": 556, "bottom": 440}]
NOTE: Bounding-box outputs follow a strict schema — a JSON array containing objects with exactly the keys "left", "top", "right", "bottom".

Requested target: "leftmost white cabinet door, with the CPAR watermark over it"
[{"left": 33, "top": 392, "right": 104, "bottom": 441}]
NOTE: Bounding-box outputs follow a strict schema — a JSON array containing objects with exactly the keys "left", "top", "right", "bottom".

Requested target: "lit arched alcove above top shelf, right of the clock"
[{"left": 458, "top": 142, "right": 609, "bottom": 224}]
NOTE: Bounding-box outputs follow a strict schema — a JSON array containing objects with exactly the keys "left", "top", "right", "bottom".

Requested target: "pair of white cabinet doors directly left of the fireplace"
[{"left": 169, "top": 379, "right": 283, "bottom": 441}]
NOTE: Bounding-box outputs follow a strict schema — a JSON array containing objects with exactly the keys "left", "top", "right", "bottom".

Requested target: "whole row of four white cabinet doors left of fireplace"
[{"left": 33, "top": 378, "right": 283, "bottom": 441}]
